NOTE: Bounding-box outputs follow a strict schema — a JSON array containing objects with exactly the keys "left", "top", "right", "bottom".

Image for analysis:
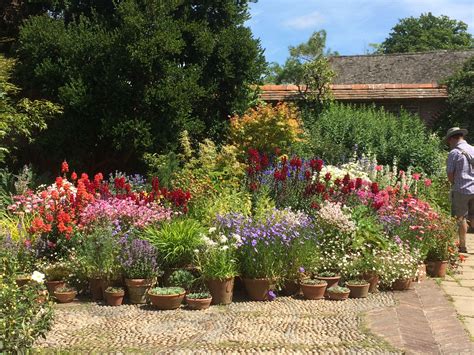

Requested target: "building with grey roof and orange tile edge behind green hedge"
[{"left": 260, "top": 50, "right": 474, "bottom": 124}]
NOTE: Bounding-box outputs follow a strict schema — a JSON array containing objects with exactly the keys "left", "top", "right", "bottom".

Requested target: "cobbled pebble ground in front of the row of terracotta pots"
[{"left": 36, "top": 293, "right": 400, "bottom": 354}]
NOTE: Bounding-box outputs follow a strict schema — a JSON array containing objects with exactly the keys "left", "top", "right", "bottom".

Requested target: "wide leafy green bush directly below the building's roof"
[{"left": 306, "top": 103, "right": 442, "bottom": 173}]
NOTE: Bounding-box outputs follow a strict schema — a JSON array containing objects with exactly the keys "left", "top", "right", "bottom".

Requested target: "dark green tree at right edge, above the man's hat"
[{"left": 440, "top": 57, "right": 474, "bottom": 132}]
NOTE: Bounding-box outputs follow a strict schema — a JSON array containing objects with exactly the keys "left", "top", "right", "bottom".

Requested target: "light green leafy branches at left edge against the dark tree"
[{"left": 0, "top": 55, "right": 61, "bottom": 167}]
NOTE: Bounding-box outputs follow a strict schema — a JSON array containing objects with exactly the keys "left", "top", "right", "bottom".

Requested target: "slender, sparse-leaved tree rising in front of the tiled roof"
[{"left": 267, "top": 30, "right": 338, "bottom": 111}]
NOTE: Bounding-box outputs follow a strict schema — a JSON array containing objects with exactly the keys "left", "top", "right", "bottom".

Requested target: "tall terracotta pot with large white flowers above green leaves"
[{"left": 195, "top": 228, "right": 240, "bottom": 305}]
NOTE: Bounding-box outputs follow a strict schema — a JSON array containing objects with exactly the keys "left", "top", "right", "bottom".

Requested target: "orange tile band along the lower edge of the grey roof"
[{"left": 260, "top": 83, "right": 447, "bottom": 101}]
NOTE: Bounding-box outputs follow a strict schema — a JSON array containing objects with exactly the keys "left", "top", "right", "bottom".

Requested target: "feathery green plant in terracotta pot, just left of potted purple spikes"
[{"left": 76, "top": 224, "right": 120, "bottom": 301}]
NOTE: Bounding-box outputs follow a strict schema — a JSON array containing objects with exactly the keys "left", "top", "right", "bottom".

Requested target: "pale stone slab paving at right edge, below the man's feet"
[{"left": 441, "top": 234, "right": 474, "bottom": 340}]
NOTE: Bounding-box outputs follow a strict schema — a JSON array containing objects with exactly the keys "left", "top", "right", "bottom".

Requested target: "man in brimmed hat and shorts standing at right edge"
[{"left": 445, "top": 127, "right": 474, "bottom": 253}]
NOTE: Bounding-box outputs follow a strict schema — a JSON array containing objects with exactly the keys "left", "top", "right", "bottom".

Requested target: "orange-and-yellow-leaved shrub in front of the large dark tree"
[{"left": 230, "top": 103, "right": 303, "bottom": 158}]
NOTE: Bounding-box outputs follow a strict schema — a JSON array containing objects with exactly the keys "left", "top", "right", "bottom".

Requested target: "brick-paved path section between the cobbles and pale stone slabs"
[{"left": 367, "top": 280, "right": 474, "bottom": 354}]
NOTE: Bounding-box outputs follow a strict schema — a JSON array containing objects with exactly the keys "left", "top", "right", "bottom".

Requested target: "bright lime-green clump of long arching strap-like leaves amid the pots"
[{"left": 140, "top": 218, "right": 205, "bottom": 268}]
